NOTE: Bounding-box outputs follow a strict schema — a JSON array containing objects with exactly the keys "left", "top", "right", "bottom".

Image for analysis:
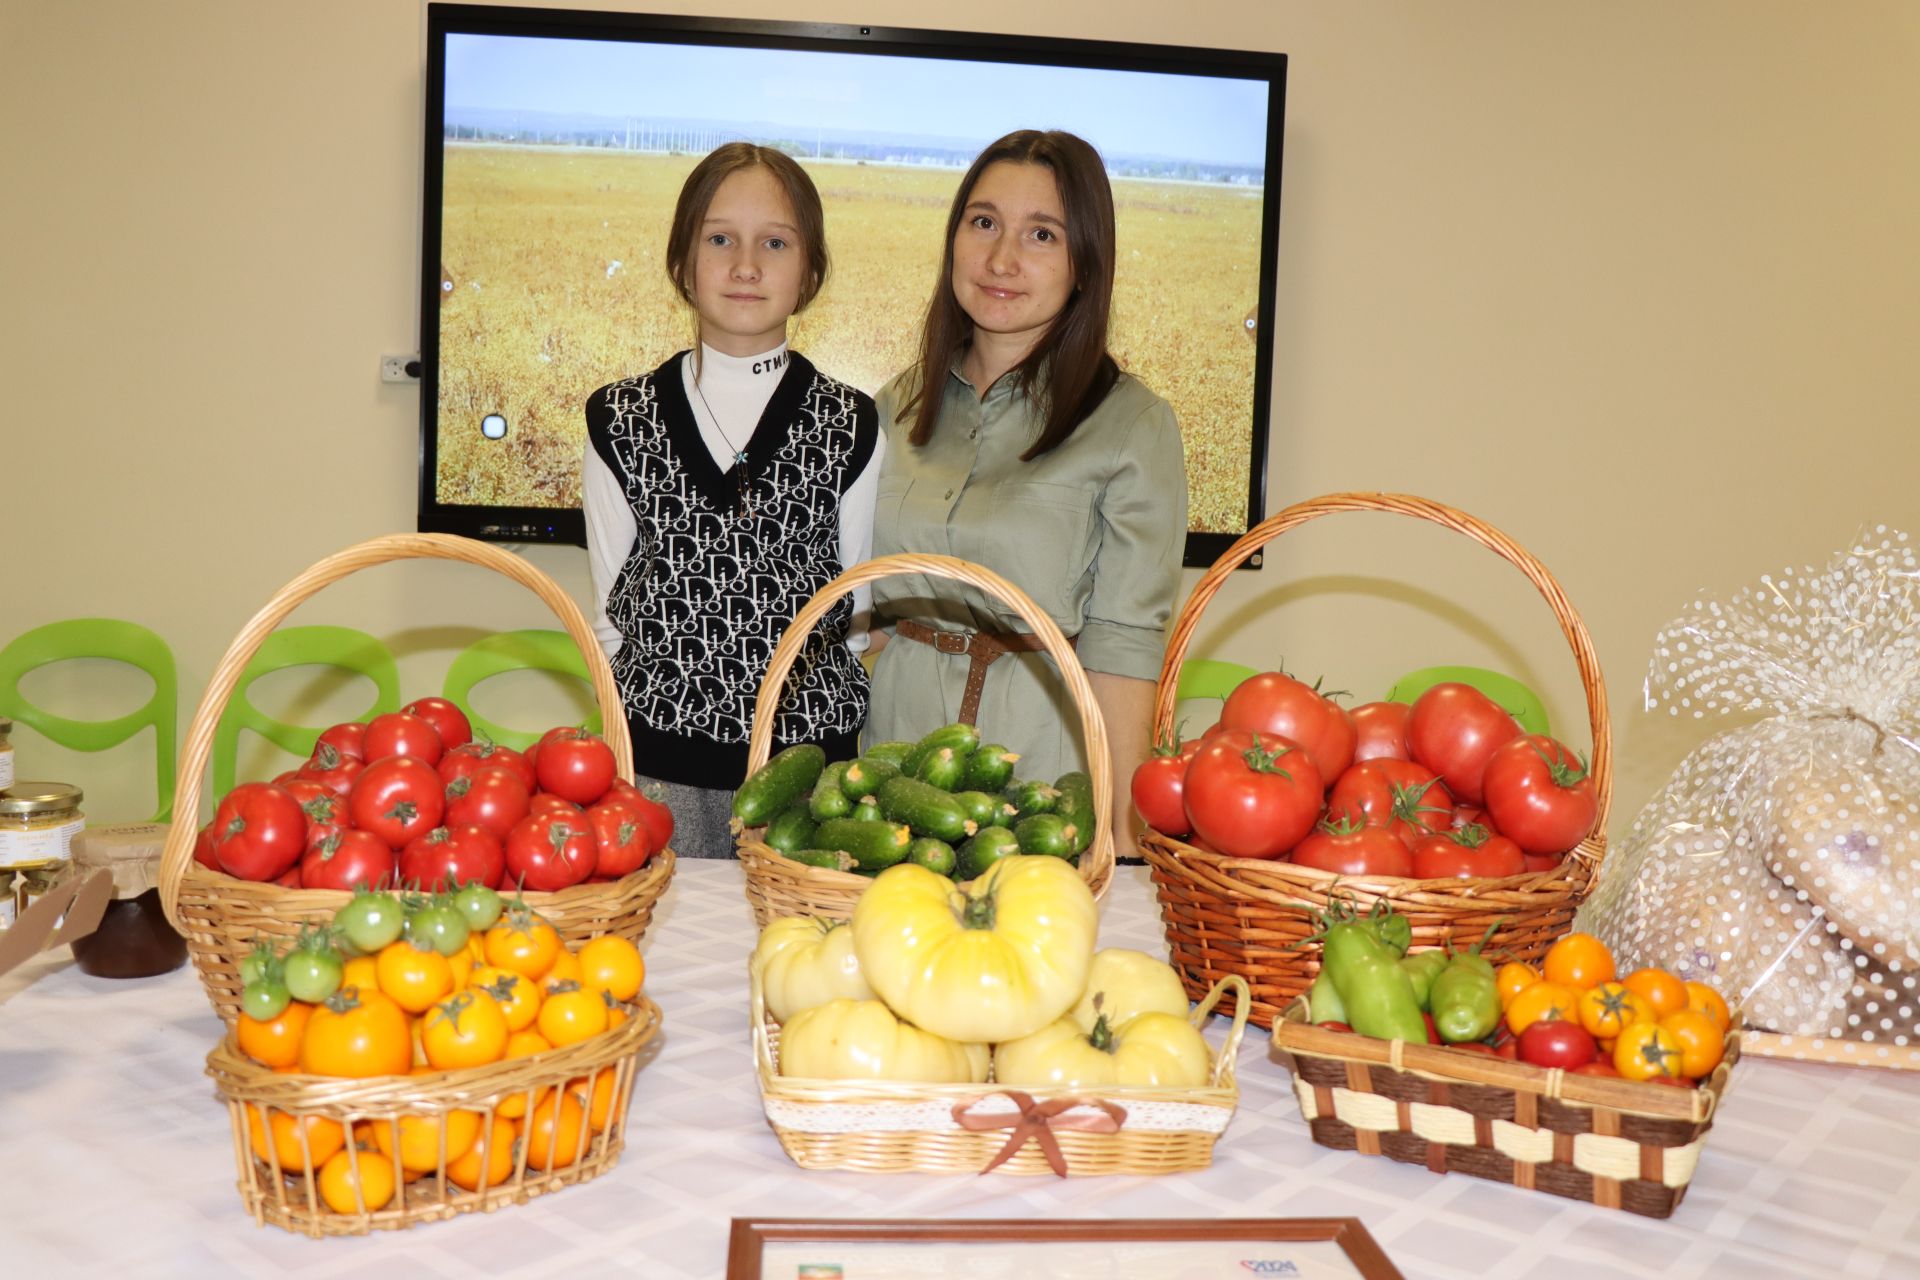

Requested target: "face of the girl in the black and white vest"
[{"left": 691, "top": 165, "right": 806, "bottom": 355}]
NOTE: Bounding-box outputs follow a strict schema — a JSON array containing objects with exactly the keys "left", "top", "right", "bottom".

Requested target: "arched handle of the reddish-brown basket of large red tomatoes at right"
[{"left": 1154, "top": 493, "right": 1613, "bottom": 831}]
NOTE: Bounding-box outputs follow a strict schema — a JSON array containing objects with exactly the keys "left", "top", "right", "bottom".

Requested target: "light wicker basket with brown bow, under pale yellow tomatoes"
[{"left": 753, "top": 975, "right": 1248, "bottom": 1176}]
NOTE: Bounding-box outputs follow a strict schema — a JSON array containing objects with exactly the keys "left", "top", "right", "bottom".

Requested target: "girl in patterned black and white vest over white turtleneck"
[{"left": 582, "top": 142, "right": 883, "bottom": 858}]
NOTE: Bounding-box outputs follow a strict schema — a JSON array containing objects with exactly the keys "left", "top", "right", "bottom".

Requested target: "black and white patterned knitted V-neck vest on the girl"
[{"left": 586, "top": 351, "right": 879, "bottom": 787}]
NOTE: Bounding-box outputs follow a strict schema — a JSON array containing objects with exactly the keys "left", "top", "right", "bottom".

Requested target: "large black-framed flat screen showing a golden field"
[{"left": 419, "top": 4, "right": 1286, "bottom": 564}]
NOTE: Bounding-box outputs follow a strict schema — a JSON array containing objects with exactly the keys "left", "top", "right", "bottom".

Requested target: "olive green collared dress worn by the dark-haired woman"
[{"left": 864, "top": 361, "right": 1187, "bottom": 787}]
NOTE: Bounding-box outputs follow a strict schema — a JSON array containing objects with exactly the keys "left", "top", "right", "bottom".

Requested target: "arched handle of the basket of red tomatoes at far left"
[{"left": 159, "top": 533, "right": 634, "bottom": 929}]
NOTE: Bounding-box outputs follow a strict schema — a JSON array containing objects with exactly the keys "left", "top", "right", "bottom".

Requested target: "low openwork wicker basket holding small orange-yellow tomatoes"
[{"left": 207, "top": 996, "right": 660, "bottom": 1238}]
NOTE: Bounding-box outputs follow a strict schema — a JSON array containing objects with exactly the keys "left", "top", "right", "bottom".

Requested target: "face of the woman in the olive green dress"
[{"left": 952, "top": 159, "right": 1073, "bottom": 360}]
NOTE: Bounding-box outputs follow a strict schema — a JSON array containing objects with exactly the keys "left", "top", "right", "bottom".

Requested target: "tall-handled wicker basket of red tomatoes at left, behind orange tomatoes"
[{"left": 159, "top": 533, "right": 674, "bottom": 1025}]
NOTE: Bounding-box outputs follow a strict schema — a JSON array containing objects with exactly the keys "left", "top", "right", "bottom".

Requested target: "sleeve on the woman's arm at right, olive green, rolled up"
[{"left": 1077, "top": 397, "right": 1187, "bottom": 679}]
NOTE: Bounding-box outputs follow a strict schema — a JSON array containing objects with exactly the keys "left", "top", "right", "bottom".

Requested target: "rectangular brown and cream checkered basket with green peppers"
[{"left": 1269, "top": 1000, "right": 1740, "bottom": 1219}]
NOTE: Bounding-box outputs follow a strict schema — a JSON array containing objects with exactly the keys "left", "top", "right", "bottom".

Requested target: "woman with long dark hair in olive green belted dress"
[{"left": 866, "top": 130, "right": 1187, "bottom": 850}]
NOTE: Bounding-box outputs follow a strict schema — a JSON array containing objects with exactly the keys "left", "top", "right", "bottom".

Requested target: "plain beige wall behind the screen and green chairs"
[{"left": 0, "top": 0, "right": 1920, "bottom": 833}]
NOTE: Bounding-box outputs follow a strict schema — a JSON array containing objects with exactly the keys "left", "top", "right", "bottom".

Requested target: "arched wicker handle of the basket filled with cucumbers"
[{"left": 747, "top": 555, "right": 1114, "bottom": 879}]
